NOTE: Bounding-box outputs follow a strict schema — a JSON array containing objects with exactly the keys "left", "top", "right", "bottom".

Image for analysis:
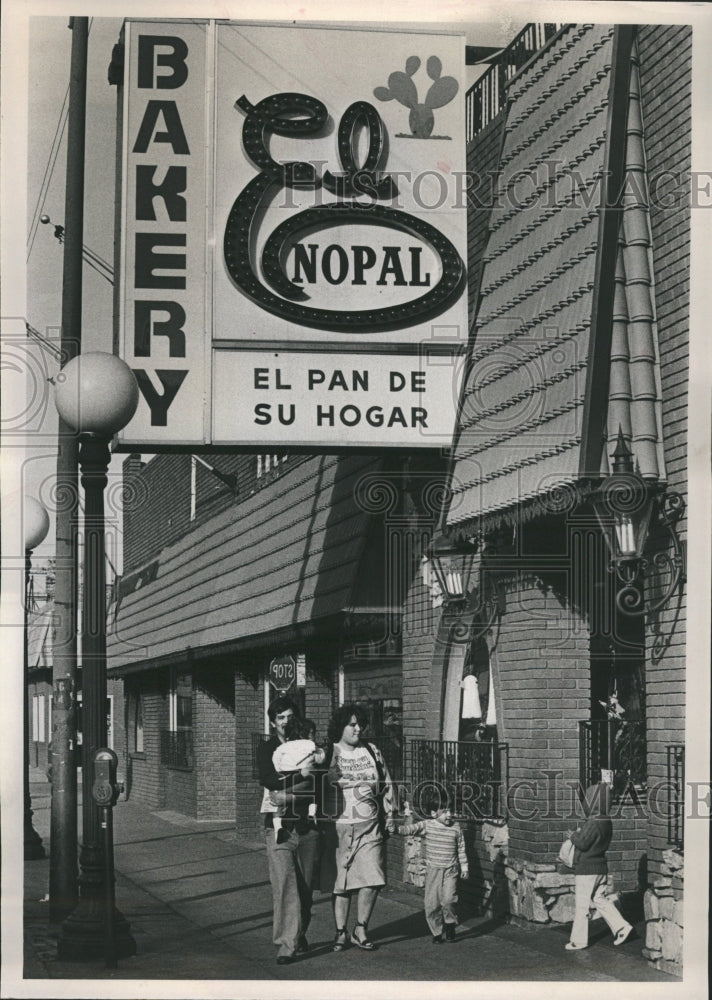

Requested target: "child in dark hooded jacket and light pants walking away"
[{"left": 565, "top": 782, "right": 633, "bottom": 951}]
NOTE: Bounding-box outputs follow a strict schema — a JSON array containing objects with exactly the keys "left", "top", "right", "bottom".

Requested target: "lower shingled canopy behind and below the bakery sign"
[{"left": 108, "top": 455, "right": 379, "bottom": 674}]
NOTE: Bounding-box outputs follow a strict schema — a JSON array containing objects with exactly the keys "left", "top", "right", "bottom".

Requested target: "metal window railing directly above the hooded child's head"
[{"left": 579, "top": 719, "right": 648, "bottom": 795}]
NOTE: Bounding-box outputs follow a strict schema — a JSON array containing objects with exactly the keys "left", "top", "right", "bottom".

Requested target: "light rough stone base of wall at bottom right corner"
[{"left": 643, "top": 849, "right": 684, "bottom": 976}]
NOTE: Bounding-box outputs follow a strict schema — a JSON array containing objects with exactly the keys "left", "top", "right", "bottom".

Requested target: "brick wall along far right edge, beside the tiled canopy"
[{"left": 638, "top": 25, "right": 692, "bottom": 880}]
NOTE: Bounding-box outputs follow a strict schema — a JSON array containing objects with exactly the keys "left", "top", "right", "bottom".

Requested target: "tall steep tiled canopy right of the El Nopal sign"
[{"left": 447, "top": 25, "right": 664, "bottom": 534}]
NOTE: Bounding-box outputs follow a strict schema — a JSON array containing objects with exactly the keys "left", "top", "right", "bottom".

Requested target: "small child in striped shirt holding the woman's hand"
[{"left": 398, "top": 785, "right": 470, "bottom": 944}]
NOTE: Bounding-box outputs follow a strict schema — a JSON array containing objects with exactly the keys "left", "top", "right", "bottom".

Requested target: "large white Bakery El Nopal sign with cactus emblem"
[{"left": 118, "top": 20, "right": 467, "bottom": 450}]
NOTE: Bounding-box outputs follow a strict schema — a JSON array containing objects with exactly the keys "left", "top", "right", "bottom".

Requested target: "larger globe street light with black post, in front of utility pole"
[{"left": 55, "top": 351, "right": 139, "bottom": 961}]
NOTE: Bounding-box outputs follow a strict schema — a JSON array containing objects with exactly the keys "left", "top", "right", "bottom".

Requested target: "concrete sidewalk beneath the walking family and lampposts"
[{"left": 24, "top": 772, "right": 677, "bottom": 995}]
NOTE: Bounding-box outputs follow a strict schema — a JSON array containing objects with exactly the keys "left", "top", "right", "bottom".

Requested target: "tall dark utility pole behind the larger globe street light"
[{"left": 49, "top": 17, "right": 89, "bottom": 921}]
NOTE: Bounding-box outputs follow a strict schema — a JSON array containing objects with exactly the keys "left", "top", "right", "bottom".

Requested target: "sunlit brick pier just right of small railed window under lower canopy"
[{"left": 193, "top": 664, "right": 236, "bottom": 820}]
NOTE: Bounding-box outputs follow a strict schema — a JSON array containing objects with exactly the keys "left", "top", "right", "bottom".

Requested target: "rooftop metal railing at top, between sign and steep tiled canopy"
[{"left": 465, "top": 24, "right": 563, "bottom": 142}]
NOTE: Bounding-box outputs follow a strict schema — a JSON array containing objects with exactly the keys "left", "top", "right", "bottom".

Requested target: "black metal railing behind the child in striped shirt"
[{"left": 404, "top": 739, "right": 508, "bottom": 819}]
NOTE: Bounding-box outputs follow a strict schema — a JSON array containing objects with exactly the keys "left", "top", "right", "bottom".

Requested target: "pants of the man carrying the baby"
[{"left": 265, "top": 829, "right": 319, "bottom": 957}]
